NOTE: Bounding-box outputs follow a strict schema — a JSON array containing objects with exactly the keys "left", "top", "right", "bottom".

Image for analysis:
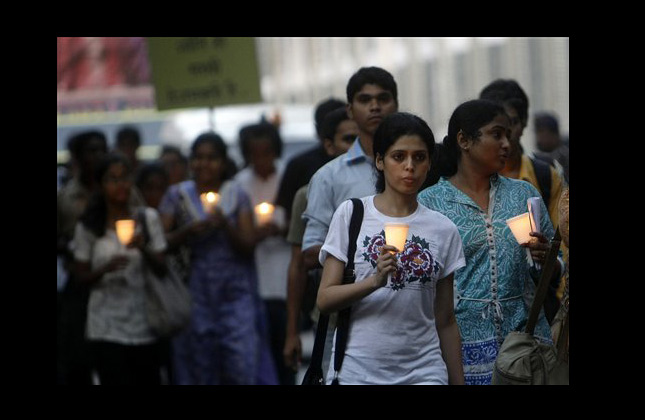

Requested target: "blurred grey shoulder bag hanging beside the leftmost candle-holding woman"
[{"left": 139, "top": 209, "right": 191, "bottom": 337}]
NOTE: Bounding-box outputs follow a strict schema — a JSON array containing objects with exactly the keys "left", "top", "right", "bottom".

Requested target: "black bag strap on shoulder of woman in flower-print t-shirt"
[{"left": 331, "top": 198, "right": 363, "bottom": 385}]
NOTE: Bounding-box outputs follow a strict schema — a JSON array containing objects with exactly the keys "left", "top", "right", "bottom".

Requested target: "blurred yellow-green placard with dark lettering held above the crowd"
[{"left": 147, "top": 37, "right": 262, "bottom": 110}]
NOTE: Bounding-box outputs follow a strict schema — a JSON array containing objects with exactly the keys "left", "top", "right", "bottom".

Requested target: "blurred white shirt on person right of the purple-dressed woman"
[{"left": 235, "top": 161, "right": 291, "bottom": 300}]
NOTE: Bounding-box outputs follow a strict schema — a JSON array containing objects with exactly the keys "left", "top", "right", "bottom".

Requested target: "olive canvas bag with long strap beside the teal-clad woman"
[{"left": 492, "top": 230, "right": 569, "bottom": 385}]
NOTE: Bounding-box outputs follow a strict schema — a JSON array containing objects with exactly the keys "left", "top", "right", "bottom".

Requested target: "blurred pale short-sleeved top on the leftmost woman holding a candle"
[{"left": 73, "top": 207, "right": 166, "bottom": 345}]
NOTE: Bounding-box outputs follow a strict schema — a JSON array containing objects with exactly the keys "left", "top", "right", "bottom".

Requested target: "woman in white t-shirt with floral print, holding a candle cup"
[{"left": 317, "top": 112, "right": 465, "bottom": 385}]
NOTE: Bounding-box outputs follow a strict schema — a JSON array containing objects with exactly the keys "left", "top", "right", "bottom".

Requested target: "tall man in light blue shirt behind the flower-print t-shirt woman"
[{"left": 302, "top": 67, "right": 399, "bottom": 269}]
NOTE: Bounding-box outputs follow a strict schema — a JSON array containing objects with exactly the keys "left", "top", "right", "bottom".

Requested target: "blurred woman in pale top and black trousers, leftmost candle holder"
[{"left": 73, "top": 154, "right": 166, "bottom": 385}]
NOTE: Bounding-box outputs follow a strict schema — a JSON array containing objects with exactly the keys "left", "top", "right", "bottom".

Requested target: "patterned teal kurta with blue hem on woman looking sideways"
[{"left": 417, "top": 175, "right": 554, "bottom": 385}]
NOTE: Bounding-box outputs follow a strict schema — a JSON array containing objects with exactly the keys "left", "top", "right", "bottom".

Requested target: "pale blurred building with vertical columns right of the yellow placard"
[{"left": 257, "top": 38, "right": 569, "bottom": 156}]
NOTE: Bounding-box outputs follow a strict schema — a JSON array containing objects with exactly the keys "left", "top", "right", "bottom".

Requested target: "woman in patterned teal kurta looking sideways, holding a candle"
[{"left": 418, "top": 99, "right": 559, "bottom": 385}]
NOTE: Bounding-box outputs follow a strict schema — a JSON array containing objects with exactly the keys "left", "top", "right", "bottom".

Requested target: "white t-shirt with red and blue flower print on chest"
[{"left": 319, "top": 195, "right": 465, "bottom": 385}]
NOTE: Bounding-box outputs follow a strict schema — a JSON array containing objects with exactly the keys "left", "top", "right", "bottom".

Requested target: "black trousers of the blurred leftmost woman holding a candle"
[{"left": 91, "top": 341, "right": 161, "bottom": 385}]
